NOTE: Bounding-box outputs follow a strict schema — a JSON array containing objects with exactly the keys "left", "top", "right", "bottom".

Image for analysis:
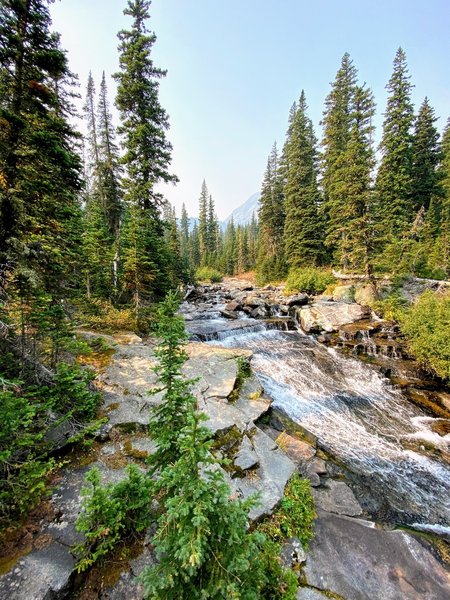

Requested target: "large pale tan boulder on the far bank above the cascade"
[{"left": 298, "top": 302, "right": 369, "bottom": 333}]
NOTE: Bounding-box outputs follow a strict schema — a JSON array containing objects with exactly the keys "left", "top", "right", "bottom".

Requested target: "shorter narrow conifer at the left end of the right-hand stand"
[{"left": 257, "top": 142, "right": 286, "bottom": 283}]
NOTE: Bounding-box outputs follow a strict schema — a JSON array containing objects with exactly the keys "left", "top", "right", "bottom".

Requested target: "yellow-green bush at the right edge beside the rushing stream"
[{"left": 398, "top": 290, "right": 450, "bottom": 379}]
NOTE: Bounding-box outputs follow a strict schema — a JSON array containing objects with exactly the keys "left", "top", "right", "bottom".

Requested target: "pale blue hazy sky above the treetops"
[{"left": 51, "top": 0, "right": 450, "bottom": 218}]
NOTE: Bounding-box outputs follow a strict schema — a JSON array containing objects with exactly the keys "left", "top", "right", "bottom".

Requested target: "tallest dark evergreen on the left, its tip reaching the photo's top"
[{"left": 114, "top": 0, "right": 176, "bottom": 308}]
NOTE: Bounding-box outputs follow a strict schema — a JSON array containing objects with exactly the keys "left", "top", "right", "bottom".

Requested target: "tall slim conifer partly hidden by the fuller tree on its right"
[{"left": 321, "top": 52, "right": 357, "bottom": 254}]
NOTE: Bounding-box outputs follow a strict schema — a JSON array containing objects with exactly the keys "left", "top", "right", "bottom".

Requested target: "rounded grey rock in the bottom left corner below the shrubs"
[{"left": 0, "top": 543, "right": 75, "bottom": 600}]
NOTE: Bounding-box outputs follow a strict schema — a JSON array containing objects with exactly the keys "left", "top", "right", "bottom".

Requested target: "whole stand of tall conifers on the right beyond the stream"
[{"left": 256, "top": 48, "right": 450, "bottom": 282}]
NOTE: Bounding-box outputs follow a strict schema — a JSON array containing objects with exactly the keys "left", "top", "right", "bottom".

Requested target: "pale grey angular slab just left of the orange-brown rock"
[{"left": 230, "top": 429, "right": 295, "bottom": 520}]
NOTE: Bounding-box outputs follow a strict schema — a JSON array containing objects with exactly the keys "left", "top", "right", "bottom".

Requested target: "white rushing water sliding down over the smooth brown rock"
[{"left": 204, "top": 322, "right": 450, "bottom": 531}]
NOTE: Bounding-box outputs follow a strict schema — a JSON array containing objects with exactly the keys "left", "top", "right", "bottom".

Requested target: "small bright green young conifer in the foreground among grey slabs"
[{"left": 141, "top": 294, "right": 265, "bottom": 600}]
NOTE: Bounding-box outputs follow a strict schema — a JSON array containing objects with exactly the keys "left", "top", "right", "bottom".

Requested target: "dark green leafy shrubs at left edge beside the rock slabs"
[{"left": 0, "top": 357, "right": 100, "bottom": 525}]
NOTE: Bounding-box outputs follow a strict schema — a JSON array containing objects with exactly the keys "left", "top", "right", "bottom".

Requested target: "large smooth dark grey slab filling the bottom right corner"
[{"left": 300, "top": 511, "right": 450, "bottom": 600}]
